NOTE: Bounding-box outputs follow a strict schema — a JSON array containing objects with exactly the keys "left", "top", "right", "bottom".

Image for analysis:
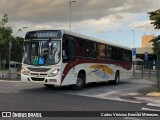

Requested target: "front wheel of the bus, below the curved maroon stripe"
[{"left": 72, "top": 74, "right": 85, "bottom": 90}]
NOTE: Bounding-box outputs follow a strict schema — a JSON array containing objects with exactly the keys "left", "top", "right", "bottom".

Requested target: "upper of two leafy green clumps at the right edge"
[{"left": 148, "top": 9, "right": 160, "bottom": 29}]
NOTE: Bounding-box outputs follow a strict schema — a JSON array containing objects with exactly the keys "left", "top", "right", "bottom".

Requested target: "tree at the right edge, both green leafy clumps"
[{"left": 148, "top": 9, "right": 160, "bottom": 53}]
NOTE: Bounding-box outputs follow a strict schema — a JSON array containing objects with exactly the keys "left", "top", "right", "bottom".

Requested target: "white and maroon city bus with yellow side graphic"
[{"left": 21, "top": 30, "right": 132, "bottom": 89}]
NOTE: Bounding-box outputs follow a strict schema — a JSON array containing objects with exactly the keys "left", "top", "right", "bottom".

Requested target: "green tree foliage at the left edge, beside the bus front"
[{"left": 0, "top": 14, "right": 23, "bottom": 66}]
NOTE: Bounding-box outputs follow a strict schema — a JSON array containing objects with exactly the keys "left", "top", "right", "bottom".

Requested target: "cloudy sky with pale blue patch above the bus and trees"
[{"left": 0, "top": 0, "right": 160, "bottom": 48}]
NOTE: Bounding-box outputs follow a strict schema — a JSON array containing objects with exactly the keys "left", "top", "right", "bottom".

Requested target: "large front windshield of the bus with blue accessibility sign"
[{"left": 22, "top": 40, "right": 60, "bottom": 66}]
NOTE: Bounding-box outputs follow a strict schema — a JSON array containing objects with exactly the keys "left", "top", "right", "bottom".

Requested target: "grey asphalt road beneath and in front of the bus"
[{"left": 0, "top": 79, "right": 160, "bottom": 120}]
